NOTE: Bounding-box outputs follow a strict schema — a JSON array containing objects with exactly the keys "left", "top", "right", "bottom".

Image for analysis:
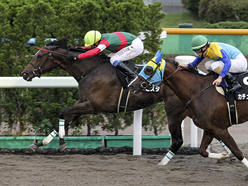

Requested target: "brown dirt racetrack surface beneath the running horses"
[{"left": 0, "top": 141, "right": 248, "bottom": 186}]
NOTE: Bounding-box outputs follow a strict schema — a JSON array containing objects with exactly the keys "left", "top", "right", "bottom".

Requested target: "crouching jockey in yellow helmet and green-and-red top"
[{"left": 70, "top": 30, "right": 144, "bottom": 82}]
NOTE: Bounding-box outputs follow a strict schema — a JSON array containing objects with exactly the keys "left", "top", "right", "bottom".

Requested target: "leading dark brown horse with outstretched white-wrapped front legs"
[{"left": 22, "top": 39, "right": 192, "bottom": 153}]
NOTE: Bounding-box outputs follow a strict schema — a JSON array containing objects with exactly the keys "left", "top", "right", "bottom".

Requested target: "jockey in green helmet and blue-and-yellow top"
[{"left": 179, "top": 35, "right": 247, "bottom": 92}]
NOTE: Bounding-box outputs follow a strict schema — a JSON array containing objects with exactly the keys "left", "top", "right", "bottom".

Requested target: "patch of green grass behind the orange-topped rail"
[{"left": 160, "top": 12, "right": 208, "bottom": 28}]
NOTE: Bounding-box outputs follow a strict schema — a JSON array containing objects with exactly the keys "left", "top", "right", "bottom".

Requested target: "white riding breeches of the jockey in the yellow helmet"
[{"left": 108, "top": 38, "right": 144, "bottom": 65}]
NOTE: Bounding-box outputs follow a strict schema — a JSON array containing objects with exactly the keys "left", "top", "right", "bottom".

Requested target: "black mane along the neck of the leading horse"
[{"left": 47, "top": 37, "right": 109, "bottom": 59}]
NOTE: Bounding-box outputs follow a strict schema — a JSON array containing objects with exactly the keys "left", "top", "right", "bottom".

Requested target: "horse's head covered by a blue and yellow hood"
[{"left": 129, "top": 51, "right": 165, "bottom": 94}]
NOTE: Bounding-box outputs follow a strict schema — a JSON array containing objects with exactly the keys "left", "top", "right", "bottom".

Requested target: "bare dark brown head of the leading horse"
[{"left": 21, "top": 38, "right": 67, "bottom": 81}]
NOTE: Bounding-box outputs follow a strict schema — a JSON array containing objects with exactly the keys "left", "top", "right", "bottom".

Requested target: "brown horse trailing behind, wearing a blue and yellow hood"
[{"left": 130, "top": 53, "right": 248, "bottom": 167}]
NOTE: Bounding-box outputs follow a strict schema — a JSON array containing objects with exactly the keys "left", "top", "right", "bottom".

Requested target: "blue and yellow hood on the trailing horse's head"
[{"left": 139, "top": 50, "right": 166, "bottom": 86}]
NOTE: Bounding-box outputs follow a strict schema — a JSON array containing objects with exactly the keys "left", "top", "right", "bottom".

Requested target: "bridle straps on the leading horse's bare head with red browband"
[{"left": 29, "top": 46, "right": 69, "bottom": 77}]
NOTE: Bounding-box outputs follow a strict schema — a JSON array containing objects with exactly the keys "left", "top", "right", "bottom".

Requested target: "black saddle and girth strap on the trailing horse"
[{"left": 216, "top": 71, "right": 248, "bottom": 125}]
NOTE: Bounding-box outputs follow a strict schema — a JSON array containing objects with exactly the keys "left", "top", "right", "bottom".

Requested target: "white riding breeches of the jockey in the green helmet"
[{"left": 205, "top": 53, "right": 247, "bottom": 73}]
